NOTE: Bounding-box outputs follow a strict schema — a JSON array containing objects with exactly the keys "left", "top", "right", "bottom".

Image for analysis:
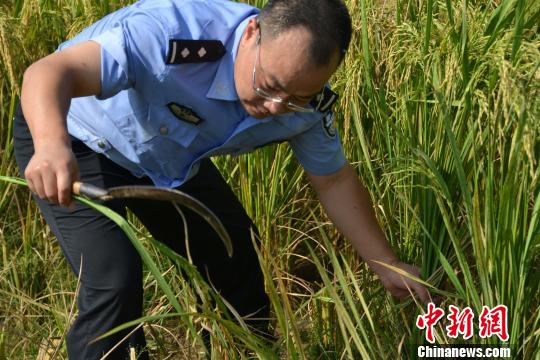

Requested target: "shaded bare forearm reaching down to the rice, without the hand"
[{"left": 310, "top": 165, "right": 398, "bottom": 271}]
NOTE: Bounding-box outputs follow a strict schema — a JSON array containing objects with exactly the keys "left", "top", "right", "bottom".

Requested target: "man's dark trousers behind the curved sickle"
[{"left": 14, "top": 107, "right": 269, "bottom": 359}]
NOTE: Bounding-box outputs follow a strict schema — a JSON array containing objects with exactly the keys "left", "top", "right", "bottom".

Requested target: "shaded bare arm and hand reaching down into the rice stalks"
[{"left": 308, "top": 164, "right": 429, "bottom": 302}]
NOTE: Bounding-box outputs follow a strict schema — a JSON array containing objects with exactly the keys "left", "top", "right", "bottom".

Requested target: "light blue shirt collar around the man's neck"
[{"left": 206, "top": 15, "right": 256, "bottom": 101}]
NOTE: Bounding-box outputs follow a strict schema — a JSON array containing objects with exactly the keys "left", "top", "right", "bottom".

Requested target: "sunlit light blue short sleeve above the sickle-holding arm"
[{"left": 90, "top": 12, "right": 167, "bottom": 99}]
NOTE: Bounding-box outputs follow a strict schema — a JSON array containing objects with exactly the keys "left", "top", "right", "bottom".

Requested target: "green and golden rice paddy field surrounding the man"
[{"left": 0, "top": 0, "right": 540, "bottom": 359}]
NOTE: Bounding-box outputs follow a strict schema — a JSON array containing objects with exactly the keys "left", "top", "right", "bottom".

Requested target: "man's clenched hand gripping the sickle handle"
[{"left": 24, "top": 144, "right": 79, "bottom": 207}]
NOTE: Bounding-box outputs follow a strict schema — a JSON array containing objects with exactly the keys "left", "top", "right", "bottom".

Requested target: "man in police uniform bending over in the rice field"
[{"left": 15, "top": 0, "right": 427, "bottom": 359}]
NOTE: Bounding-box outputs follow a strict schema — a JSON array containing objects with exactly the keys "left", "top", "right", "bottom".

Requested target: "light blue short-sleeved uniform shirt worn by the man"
[{"left": 59, "top": 0, "right": 346, "bottom": 187}]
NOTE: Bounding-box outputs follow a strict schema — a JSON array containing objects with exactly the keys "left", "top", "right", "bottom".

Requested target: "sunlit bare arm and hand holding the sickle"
[{"left": 21, "top": 41, "right": 101, "bottom": 205}]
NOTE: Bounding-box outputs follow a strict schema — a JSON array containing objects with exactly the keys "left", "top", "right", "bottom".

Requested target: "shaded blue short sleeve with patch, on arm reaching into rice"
[{"left": 289, "top": 112, "right": 347, "bottom": 176}]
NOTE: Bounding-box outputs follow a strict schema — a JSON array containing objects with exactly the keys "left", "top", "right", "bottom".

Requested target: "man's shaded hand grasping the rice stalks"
[{"left": 372, "top": 260, "right": 430, "bottom": 304}]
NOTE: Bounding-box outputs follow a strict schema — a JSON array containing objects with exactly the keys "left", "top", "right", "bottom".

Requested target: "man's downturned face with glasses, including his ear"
[{"left": 234, "top": 19, "right": 338, "bottom": 119}]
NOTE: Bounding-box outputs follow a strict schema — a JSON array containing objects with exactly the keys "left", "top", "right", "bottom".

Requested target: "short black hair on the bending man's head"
[{"left": 258, "top": 0, "right": 352, "bottom": 66}]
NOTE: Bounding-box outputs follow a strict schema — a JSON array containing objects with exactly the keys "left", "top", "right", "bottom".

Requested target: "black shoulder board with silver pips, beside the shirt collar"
[{"left": 166, "top": 39, "right": 227, "bottom": 64}]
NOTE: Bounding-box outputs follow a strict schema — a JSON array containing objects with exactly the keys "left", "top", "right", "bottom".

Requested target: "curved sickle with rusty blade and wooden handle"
[{"left": 72, "top": 181, "right": 233, "bottom": 257}]
